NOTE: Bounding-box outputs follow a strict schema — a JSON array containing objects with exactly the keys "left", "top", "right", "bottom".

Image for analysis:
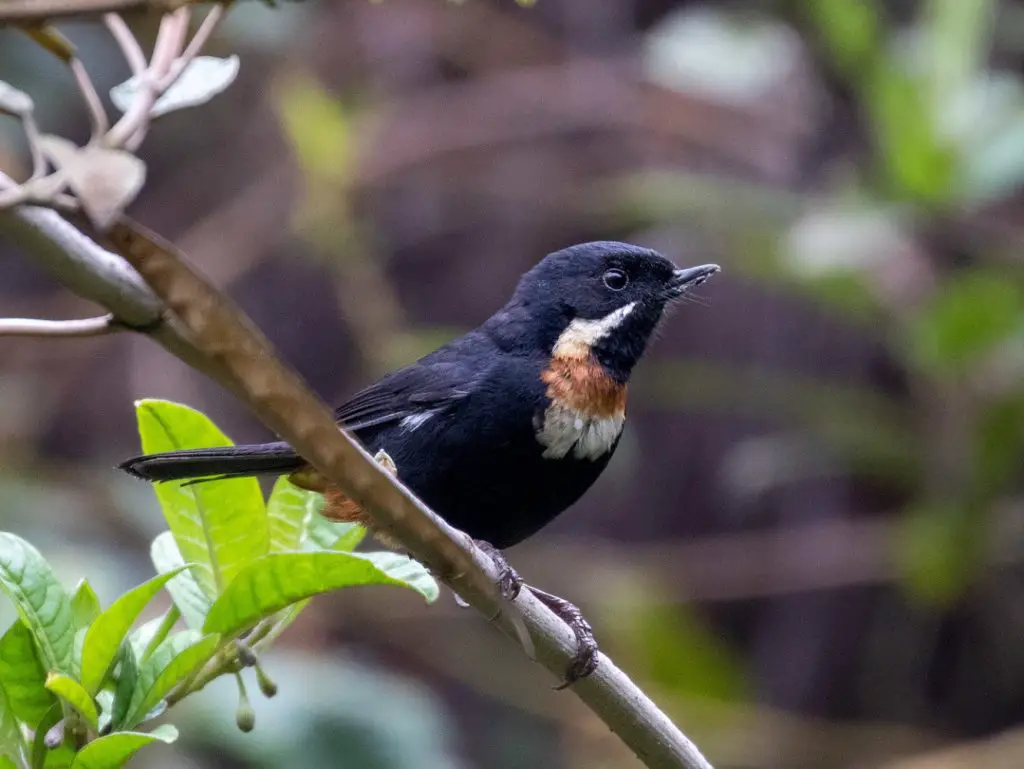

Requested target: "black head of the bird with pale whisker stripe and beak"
[{"left": 509, "top": 241, "right": 719, "bottom": 382}]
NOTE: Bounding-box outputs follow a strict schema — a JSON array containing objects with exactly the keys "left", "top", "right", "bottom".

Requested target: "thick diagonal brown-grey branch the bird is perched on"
[{"left": 0, "top": 182, "right": 711, "bottom": 769}]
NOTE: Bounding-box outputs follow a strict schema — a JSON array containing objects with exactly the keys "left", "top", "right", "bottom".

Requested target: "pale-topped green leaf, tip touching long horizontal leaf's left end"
[{"left": 120, "top": 630, "right": 220, "bottom": 729}]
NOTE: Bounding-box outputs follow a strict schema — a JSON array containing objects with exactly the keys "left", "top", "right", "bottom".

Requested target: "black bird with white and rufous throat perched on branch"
[{"left": 119, "top": 241, "right": 720, "bottom": 686}]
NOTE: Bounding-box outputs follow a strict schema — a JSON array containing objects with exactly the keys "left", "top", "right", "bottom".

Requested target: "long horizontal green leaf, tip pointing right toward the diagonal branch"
[{"left": 204, "top": 551, "right": 436, "bottom": 635}]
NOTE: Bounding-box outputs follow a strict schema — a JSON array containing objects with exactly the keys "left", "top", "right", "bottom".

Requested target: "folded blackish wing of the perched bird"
[{"left": 335, "top": 348, "right": 485, "bottom": 432}]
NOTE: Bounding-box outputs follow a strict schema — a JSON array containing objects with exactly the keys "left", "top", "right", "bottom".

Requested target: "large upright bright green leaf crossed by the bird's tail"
[{"left": 136, "top": 400, "right": 269, "bottom": 597}]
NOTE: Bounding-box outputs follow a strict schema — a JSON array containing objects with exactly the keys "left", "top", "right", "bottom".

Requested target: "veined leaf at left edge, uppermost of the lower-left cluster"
[{"left": 0, "top": 531, "right": 75, "bottom": 672}]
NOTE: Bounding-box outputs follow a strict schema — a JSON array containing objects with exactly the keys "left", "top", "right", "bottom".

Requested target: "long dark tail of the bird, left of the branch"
[{"left": 118, "top": 442, "right": 305, "bottom": 481}]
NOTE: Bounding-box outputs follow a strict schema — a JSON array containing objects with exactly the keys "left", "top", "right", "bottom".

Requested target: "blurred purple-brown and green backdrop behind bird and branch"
[{"left": 0, "top": 0, "right": 1024, "bottom": 769}]
